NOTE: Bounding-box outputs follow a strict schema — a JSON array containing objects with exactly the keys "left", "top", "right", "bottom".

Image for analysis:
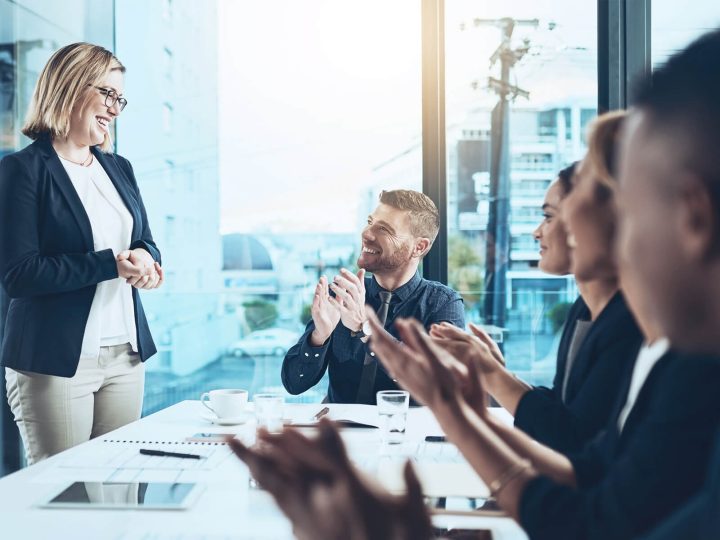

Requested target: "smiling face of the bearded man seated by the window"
[{"left": 357, "top": 203, "right": 419, "bottom": 274}]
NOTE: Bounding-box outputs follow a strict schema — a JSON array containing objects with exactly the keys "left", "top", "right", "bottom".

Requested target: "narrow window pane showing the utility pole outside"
[{"left": 445, "top": 0, "right": 597, "bottom": 384}]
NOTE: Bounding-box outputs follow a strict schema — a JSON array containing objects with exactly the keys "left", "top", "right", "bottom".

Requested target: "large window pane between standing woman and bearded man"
[{"left": 116, "top": 0, "right": 422, "bottom": 414}]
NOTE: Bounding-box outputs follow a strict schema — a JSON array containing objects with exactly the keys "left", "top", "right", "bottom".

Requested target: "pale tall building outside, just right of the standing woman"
[{"left": 115, "top": 0, "right": 233, "bottom": 375}]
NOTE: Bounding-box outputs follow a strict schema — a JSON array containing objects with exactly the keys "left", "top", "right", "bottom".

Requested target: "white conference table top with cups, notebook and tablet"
[{"left": 0, "top": 401, "right": 527, "bottom": 540}]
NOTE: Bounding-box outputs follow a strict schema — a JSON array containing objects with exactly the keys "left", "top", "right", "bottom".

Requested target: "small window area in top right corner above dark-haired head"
[{"left": 650, "top": 0, "right": 720, "bottom": 66}]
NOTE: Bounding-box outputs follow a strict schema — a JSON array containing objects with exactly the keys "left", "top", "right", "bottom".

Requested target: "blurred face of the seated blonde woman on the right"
[{"left": 562, "top": 157, "right": 617, "bottom": 281}]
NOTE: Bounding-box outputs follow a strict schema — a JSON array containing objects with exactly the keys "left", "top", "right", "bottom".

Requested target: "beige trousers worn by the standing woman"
[{"left": 5, "top": 344, "right": 145, "bottom": 465}]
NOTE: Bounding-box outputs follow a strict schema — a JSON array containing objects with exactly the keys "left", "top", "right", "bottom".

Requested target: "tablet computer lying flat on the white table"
[{"left": 39, "top": 482, "right": 202, "bottom": 510}]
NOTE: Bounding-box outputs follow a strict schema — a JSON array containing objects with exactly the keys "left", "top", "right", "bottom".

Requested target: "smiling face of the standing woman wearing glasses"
[{"left": 68, "top": 69, "right": 124, "bottom": 146}]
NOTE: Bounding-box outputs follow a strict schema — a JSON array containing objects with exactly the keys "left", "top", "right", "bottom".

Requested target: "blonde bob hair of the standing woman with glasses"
[{"left": 22, "top": 43, "right": 125, "bottom": 152}]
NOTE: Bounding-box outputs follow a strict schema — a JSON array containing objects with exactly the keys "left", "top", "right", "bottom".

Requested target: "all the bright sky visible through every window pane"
[{"left": 219, "top": 0, "right": 720, "bottom": 233}]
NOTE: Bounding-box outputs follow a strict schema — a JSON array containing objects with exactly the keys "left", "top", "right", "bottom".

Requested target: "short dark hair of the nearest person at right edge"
[{"left": 635, "top": 30, "right": 720, "bottom": 212}]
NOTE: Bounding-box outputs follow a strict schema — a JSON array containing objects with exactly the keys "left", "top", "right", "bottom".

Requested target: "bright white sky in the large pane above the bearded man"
[{"left": 220, "top": 0, "right": 420, "bottom": 232}]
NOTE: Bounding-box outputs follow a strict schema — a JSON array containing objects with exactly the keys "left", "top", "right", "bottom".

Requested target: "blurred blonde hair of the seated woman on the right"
[{"left": 586, "top": 111, "right": 628, "bottom": 199}]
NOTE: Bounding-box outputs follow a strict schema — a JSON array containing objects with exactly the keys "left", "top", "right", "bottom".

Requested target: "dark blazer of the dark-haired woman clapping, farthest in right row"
[{"left": 515, "top": 292, "right": 643, "bottom": 453}]
